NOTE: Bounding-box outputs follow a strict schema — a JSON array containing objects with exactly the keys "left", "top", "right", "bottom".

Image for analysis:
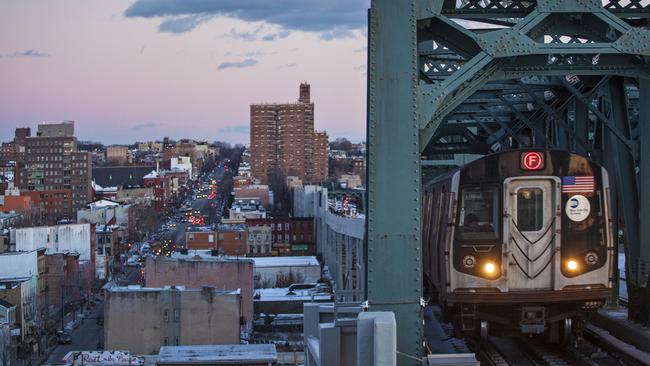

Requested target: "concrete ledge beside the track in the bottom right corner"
[{"left": 591, "top": 308, "right": 650, "bottom": 352}]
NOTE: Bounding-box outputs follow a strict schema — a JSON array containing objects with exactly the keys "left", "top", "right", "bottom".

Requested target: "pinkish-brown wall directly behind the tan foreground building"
[{"left": 145, "top": 257, "right": 253, "bottom": 331}]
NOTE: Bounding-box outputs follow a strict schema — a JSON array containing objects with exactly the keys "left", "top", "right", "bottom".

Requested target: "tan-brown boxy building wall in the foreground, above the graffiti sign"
[{"left": 104, "top": 288, "right": 240, "bottom": 355}]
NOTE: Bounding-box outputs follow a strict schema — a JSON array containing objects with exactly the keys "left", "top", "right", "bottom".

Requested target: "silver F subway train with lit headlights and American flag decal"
[{"left": 422, "top": 149, "right": 614, "bottom": 341}]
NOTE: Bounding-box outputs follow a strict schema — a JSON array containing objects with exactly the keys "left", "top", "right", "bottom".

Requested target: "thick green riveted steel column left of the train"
[{"left": 366, "top": 0, "right": 424, "bottom": 365}]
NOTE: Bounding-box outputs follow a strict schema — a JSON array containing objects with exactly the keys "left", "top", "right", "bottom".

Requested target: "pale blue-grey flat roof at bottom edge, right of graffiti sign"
[{"left": 158, "top": 344, "right": 278, "bottom": 365}]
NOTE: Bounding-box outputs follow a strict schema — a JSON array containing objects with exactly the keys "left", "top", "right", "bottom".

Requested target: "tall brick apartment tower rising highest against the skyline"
[{"left": 251, "top": 83, "right": 327, "bottom": 184}]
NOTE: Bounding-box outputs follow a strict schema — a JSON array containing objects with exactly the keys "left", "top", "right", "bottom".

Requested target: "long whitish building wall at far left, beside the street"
[{"left": 16, "top": 224, "right": 93, "bottom": 262}]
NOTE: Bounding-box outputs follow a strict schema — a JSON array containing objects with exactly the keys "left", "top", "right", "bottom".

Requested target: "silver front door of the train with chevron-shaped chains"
[{"left": 503, "top": 177, "right": 560, "bottom": 291}]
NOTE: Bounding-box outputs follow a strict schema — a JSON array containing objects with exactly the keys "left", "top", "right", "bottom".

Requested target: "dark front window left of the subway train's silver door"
[{"left": 458, "top": 187, "right": 499, "bottom": 240}]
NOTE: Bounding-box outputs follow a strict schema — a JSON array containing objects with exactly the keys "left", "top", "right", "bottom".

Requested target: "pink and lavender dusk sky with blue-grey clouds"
[{"left": 0, "top": 0, "right": 370, "bottom": 144}]
